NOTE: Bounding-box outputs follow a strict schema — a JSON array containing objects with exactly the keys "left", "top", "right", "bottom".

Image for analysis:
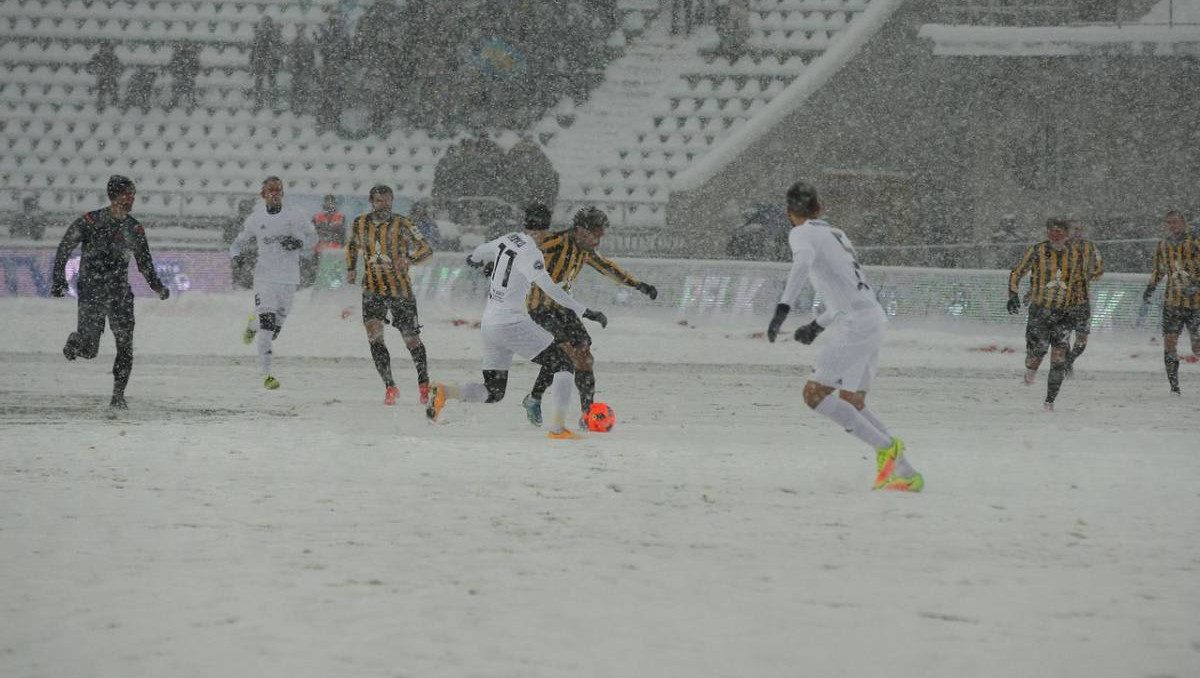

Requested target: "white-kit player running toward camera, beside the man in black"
[{"left": 229, "top": 176, "right": 317, "bottom": 389}]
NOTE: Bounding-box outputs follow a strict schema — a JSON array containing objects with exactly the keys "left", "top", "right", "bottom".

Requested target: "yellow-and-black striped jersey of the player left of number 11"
[{"left": 346, "top": 214, "right": 433, "bottom": 299}]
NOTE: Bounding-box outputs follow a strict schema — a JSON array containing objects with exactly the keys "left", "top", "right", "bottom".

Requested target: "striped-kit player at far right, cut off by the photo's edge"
[{"left": 1141, "top": 210, "right": 1200, "bottom": 395}]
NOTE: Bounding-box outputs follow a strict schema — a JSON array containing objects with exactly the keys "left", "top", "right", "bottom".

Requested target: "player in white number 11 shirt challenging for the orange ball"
[{"left": 425, "top": 210, "right": 608, "bottom": 439}]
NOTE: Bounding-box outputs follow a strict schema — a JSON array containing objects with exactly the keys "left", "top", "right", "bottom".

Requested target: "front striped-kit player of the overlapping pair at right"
[{"left": 1008, "top": 218, "right": 1090, "bottom": 410}]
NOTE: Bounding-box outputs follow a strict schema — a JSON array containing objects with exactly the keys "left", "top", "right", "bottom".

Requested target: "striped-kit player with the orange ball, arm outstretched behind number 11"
[{"left": 522, "top": 204, "right": 659, "bottom": 427}]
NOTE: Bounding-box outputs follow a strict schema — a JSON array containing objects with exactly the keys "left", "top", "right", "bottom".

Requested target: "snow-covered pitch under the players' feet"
[{"left": 0, "top": 293, "right": 1200, "bottom": 678}]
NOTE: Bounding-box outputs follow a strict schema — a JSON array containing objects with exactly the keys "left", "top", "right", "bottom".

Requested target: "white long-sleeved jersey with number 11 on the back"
[{"left": 469, "top": 232, "right": 587, "bottom": 325}]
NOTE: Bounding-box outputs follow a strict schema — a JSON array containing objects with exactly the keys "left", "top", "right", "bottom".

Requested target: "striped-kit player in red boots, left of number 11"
[{"left": 346, "top": 185, "right": 433, "bottom": 404}]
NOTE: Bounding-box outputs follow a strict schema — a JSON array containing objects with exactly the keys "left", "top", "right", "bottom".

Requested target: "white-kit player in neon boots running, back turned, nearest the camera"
[{"left": 767, "top": 181, "right": 925, "bottom": 492}]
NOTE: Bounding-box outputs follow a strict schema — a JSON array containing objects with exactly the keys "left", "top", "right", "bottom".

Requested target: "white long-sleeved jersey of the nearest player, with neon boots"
[{"left": 779, "top": 218, "right": 880, "bottom": 328}]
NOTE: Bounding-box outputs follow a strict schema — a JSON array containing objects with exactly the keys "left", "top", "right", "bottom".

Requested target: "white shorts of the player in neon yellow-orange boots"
[{"left": 812, "top": 306, "right": 888, "bottom": 391}]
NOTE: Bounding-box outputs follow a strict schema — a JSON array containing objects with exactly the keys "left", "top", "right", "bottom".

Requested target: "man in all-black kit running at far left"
[{"left": 50, "top": 174, "right": 170, "bottom": 409}]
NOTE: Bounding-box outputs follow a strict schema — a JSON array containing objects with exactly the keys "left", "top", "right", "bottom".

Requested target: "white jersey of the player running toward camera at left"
[{"left": 229, "top": 205, "right": 317, "bottom": 286}]
